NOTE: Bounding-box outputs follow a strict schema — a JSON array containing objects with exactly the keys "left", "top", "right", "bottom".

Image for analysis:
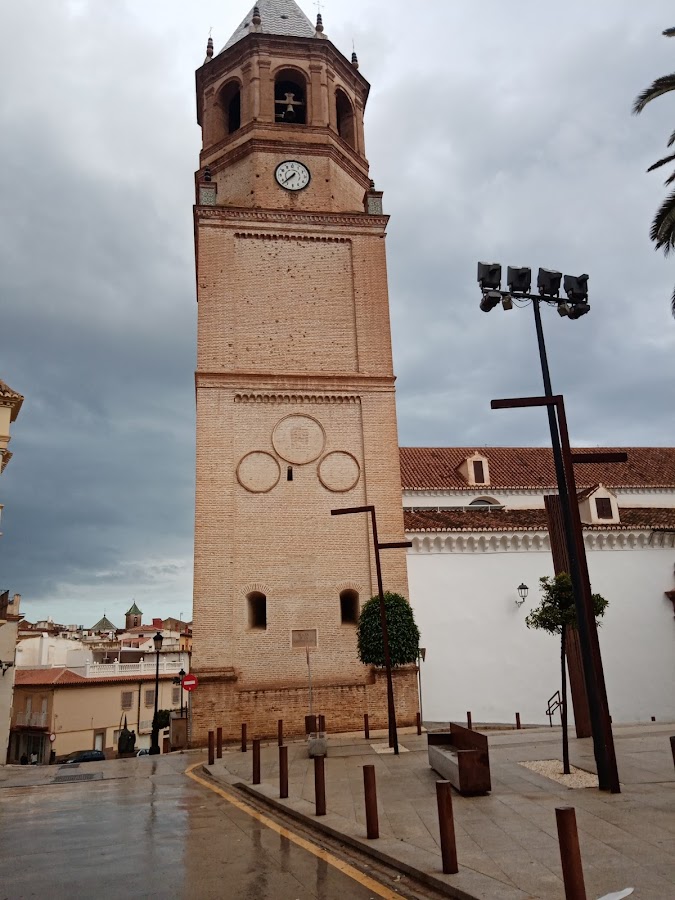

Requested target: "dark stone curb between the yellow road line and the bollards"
[{"left": 202, "top": 765, "right": 531, "bottom": 900}]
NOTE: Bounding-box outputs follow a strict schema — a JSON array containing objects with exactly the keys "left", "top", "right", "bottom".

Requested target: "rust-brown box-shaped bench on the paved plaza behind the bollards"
[{"left": 427, "top": 723, "right": 492, "bottom": 794}]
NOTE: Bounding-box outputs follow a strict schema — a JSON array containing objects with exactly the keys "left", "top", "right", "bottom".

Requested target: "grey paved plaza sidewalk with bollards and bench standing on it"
[{"left": 205, "top": 724, "right": 675, "bottom": 900}]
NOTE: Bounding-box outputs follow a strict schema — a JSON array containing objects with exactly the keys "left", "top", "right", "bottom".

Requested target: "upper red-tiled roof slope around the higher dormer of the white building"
[{"left": 400, "top": 447, "right": 675, "bottom": 494}]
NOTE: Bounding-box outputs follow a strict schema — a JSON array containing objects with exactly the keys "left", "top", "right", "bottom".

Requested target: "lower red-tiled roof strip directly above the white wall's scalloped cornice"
[{"left": 403, "top": 507, "right": 675, "bottom": 532}]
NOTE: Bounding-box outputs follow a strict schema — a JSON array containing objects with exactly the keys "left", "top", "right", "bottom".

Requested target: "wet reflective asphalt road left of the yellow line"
[{"left": 0, "top": 754, "right": 396, "bottom": 900}]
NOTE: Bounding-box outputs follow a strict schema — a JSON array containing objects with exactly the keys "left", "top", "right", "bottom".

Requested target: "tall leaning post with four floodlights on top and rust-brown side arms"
[{"left": 478, "top": 263, "right": 625, "bottom": 793}]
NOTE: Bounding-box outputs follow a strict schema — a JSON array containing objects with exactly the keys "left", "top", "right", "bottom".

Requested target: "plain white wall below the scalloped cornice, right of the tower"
[{"left": 408, "top": 548, "right": 675, "bottom": 724}]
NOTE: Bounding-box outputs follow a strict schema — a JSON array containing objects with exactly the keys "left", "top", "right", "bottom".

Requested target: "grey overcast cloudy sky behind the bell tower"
[{"left": 0, "top": 0, "right": 675, "bottom": 626}]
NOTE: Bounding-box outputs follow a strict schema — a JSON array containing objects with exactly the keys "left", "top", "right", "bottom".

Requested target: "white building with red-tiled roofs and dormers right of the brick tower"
[{"left": 401, "top": 447, "right": 675, "bottom": 723}]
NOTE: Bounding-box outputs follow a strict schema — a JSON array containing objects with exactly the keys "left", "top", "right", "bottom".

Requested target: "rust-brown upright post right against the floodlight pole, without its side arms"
[{"left": 557, "top": 398, "right": 621, "bottom": 794}]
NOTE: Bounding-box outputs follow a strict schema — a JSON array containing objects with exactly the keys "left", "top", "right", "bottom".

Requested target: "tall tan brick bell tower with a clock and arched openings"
[{"left": 187, "top": 0, "right": 417, "bottom": 743}]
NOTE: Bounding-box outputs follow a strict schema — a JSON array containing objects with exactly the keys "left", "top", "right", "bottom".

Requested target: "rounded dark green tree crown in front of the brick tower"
[{"left": 356, "top": 591, "right": 420, "bottom": 667}]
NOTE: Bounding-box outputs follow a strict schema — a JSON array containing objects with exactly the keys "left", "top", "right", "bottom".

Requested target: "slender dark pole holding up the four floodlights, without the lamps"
[{"left": 532, "top": 297, "right": 609, "bottom": 790}]
